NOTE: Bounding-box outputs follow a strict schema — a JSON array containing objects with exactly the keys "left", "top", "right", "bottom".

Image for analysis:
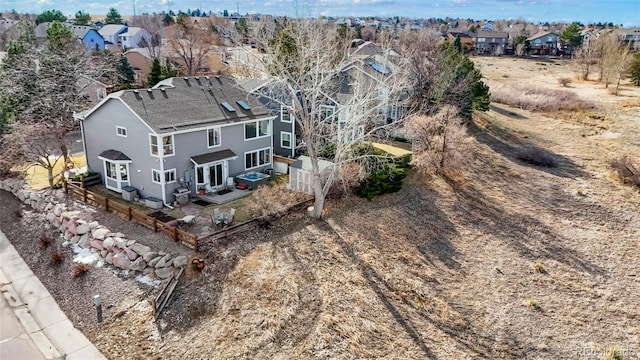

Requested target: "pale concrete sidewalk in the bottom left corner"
[{"left": 0, "top": 231, "right": 106, "bottom": 360}]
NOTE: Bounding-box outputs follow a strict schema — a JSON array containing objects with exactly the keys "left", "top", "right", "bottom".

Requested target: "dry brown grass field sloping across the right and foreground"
[{"left": 11, "top": 57, "right": 640, "bottom": 359}]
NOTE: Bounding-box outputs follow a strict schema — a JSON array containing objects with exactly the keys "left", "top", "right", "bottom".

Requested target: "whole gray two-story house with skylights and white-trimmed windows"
[{"left": 77, "top": 76, "right": 274, "bottom": 204}]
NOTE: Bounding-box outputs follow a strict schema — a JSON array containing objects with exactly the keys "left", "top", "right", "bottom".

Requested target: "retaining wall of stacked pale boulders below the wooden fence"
[{"left": 0, "top": 179, "right": 187, "bottom": 280}]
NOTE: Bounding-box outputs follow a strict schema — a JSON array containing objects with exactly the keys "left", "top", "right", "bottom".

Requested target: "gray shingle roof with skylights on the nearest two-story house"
[{"left": 114, "top": 76, "right": 270, "bottom": 133}]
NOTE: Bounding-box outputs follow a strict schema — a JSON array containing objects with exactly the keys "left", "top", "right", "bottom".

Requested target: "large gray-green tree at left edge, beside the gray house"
[{"left": 0, "top": 22, "right": 115, "bottom": 180}]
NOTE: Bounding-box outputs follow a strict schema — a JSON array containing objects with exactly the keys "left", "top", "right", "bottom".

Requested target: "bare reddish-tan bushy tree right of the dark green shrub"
[{"left": 404, "top": 105, "right": 471, "bottom": 175}]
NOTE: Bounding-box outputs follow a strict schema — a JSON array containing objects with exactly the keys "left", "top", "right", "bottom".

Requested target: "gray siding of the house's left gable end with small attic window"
[{"left": 83, "top": 99, "right": 161, "bottom": 197}]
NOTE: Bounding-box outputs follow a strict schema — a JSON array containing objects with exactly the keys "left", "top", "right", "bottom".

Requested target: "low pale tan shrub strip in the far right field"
[{"left": 491, "top": 85, "right": 593, "bottom": 112}]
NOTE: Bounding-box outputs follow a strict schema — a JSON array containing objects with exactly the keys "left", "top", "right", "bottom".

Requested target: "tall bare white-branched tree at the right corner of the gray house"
[{"left": 245, "top": 19, "right": 406, "bottom": 218}]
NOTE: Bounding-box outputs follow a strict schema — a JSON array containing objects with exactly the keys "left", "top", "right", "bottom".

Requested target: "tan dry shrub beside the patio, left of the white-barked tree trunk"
[{"left": 245, "top": 182, "right": 308, "bottom": 218}]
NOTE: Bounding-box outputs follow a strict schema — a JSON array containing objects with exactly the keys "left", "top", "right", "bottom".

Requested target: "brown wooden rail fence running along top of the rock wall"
[{"left": 64, "top": 182, "right": 198, "bottom": 251}]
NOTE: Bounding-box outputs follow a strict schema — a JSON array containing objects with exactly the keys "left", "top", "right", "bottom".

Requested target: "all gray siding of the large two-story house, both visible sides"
[{"left": 83, "top": 99, "right": 273, "bottom": 203}]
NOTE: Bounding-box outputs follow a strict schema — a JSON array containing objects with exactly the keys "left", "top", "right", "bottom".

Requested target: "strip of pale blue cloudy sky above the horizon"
[{"left": 0, "top": 0, "right": 640, "bottom": 27}]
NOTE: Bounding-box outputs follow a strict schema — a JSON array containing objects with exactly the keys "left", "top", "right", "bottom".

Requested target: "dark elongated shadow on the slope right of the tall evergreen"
[{"left": 468, "top": 117, "right": 589, "bottom": 178}]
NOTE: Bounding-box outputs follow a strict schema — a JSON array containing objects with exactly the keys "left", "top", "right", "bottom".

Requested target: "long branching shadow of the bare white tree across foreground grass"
[{"left": 326, "top": 180, "right": 533, "bottom": 358}]
